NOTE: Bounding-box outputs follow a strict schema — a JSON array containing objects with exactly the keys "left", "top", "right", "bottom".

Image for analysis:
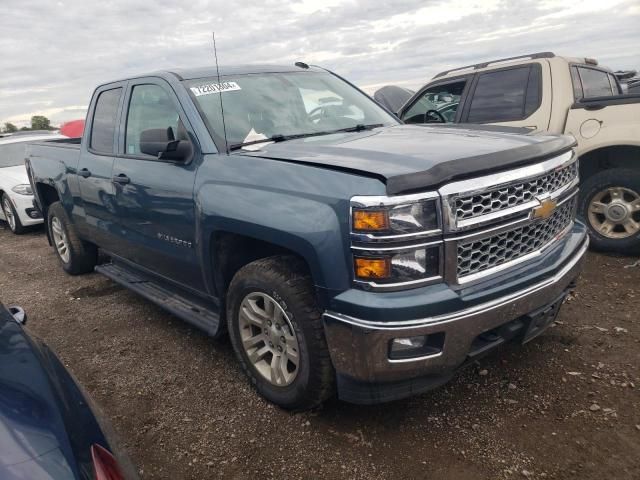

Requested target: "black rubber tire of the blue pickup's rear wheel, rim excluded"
[{"left": 47, "top": 202, "right": 98, "bottom": 275}]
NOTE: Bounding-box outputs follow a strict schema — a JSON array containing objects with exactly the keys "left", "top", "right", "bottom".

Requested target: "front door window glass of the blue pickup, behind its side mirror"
[{"left": 125, "top": 85, "right": 181, "bottom": 155}]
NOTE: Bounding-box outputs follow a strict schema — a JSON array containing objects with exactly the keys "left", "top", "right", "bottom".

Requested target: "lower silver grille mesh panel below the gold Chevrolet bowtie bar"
[{"left": 458, "top": 198, "right": 576, "bottom": 278}]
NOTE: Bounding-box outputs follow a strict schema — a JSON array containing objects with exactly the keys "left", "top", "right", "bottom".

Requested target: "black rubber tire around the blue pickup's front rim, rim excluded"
[{"left": 227, "top": 256, "right": 335, "bottom": 410}]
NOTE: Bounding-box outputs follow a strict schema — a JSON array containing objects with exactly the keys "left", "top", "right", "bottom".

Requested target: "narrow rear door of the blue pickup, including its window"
[{"left": 76, "top": 82, "right": 126, "bottom": 249}]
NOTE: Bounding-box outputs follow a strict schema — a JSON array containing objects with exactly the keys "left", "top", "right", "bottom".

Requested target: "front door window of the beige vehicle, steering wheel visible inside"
[{"left": 402, "top": 80, "right": 467, "bottom": 123}]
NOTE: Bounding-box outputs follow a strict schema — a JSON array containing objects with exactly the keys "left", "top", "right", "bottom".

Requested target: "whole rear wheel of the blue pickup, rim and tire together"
[{"left": 47, "top": 202, "right": 98, "bottom": 275}]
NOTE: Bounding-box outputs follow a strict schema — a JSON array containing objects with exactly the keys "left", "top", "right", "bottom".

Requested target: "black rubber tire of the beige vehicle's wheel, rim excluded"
[{"left": 578, "top": 168, "right": 640, "bottom": 254}]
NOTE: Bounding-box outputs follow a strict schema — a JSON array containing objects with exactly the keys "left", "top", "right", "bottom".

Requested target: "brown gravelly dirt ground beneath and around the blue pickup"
[{"left": 0, "top": 223, "right": 640, "bottom": 480}]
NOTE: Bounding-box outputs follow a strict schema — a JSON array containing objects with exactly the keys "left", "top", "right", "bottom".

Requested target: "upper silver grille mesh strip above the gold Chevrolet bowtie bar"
[{"left": 455, "top": 162, "right": 578, "bottom": 220}]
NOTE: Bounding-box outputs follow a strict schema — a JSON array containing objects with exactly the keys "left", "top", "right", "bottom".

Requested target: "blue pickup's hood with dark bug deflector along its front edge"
[{"left": 240, "top": 125, "right": 575, "bottom": 195}]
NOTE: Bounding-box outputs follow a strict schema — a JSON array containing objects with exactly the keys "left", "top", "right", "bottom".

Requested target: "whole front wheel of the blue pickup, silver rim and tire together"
[{"left": 227, "top": 256, "right": 335, "bottom": 410}]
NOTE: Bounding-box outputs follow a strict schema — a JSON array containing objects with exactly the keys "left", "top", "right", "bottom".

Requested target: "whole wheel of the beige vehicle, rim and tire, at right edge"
[{"left": 579, "top": 168, "right": 640, "bottom": 253}]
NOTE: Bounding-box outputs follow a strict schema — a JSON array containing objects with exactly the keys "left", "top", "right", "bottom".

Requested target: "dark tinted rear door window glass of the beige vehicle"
[{"left": 467, "top": 64, "right": 542, "bottom": 123}]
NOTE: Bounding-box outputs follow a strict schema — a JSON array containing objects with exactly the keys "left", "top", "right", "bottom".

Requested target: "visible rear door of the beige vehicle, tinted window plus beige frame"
[{"left": 459, "top": 61, "right": 552, "bottom": 131}]
